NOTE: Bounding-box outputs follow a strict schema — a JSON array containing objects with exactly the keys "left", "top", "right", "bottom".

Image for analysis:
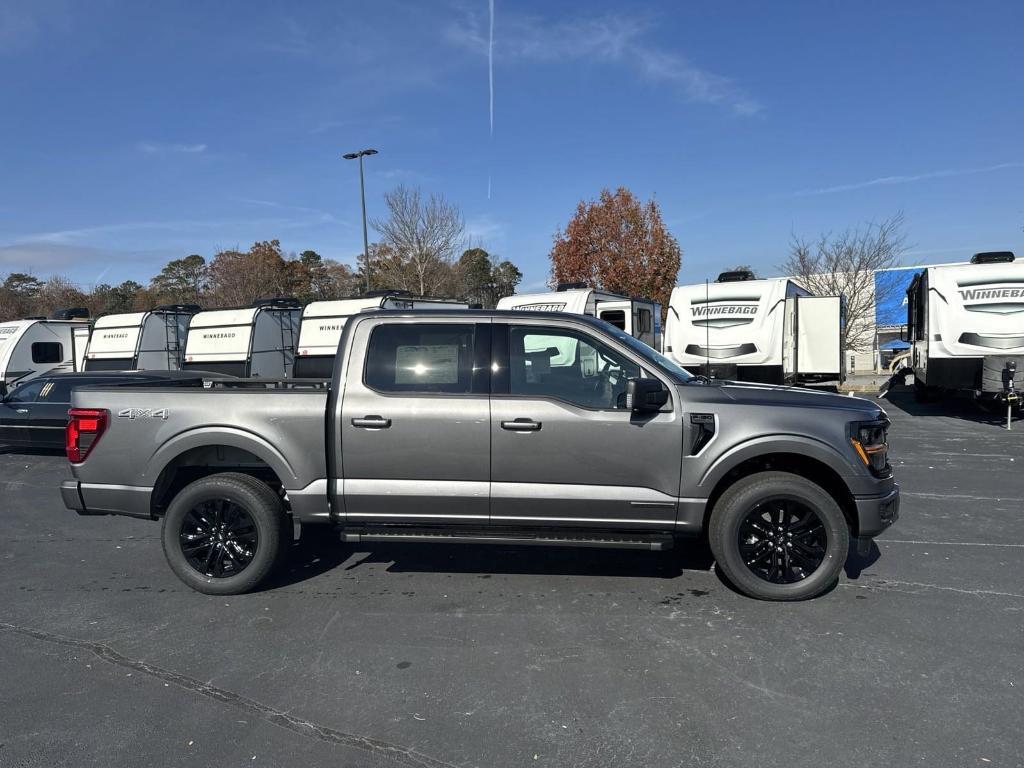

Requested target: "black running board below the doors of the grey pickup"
[{"left": 341, "top": 530, "right": 675, "bottom": 552}]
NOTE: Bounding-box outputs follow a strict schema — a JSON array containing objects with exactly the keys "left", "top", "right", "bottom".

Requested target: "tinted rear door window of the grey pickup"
[{"left": 364, "top": 324, "right": 474, "bottom": 394}]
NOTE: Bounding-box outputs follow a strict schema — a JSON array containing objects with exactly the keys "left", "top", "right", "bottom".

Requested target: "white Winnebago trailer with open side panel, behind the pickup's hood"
[{"left": 665, "top": 270, "right": 844, "bottom": 384}]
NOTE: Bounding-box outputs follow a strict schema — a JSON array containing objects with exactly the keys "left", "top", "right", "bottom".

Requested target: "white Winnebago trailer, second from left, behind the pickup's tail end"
[{"left": 85, "top": 304, "right": 200, "bottom": 371}]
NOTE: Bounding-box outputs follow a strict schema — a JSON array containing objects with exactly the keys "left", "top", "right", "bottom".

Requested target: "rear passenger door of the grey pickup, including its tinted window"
[{"left": 337, "top": 319, "right": 490, "bottom": 524}]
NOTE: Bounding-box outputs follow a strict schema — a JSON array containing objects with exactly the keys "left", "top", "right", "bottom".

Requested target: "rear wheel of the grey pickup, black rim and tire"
[{"left": 162, "top": 472, "right": 290, "bottom": 595}]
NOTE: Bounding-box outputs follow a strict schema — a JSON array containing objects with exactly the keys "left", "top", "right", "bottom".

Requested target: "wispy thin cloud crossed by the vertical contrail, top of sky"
[{"left": 444, "top": 8, "right": 763, "bottom": 117}]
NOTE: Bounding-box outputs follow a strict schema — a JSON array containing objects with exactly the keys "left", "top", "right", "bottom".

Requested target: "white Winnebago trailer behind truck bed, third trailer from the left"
[{"left": 182, "top": 299, "right": 300, "bottom": 379}]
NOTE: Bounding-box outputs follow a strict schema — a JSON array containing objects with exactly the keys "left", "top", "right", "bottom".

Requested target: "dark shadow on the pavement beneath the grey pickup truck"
[{"left": 266, "top": 531, "right": 881, "bottom": 591}]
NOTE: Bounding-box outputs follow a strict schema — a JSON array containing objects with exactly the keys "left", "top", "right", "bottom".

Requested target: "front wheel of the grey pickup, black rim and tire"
[{"left": 708, "top": 472, "right": 850, "bottom": 600}]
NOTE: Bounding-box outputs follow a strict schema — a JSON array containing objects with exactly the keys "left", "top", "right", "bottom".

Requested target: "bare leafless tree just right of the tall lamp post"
[{"left": 371, "top": 186, "right": 466, "bottom": 296}]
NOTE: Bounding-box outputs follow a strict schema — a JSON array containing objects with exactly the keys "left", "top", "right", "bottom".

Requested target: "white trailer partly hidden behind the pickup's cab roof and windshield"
[{"left": 497, "top": 283, "right": 662, "bottom": 350}]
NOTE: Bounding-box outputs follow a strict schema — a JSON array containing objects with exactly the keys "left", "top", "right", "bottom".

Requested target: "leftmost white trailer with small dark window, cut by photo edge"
[{"left": 0, "top": 307, "right": 89, "bottom": 385}]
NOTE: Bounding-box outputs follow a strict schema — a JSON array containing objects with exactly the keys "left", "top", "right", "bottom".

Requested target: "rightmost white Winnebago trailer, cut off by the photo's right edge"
[{"left": 906, "top": 251, "right": 1024, "bottom": 400}]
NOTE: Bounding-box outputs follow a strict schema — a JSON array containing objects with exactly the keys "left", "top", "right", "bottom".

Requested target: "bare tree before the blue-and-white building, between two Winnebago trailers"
[{"left": 778, "top": 212, "right": 907, "bottom": 352}]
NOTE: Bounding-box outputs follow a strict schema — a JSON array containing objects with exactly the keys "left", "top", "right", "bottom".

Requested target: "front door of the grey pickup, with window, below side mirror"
[{"left": 490, "top": 322, "right": 683, "bottom": 529}]
